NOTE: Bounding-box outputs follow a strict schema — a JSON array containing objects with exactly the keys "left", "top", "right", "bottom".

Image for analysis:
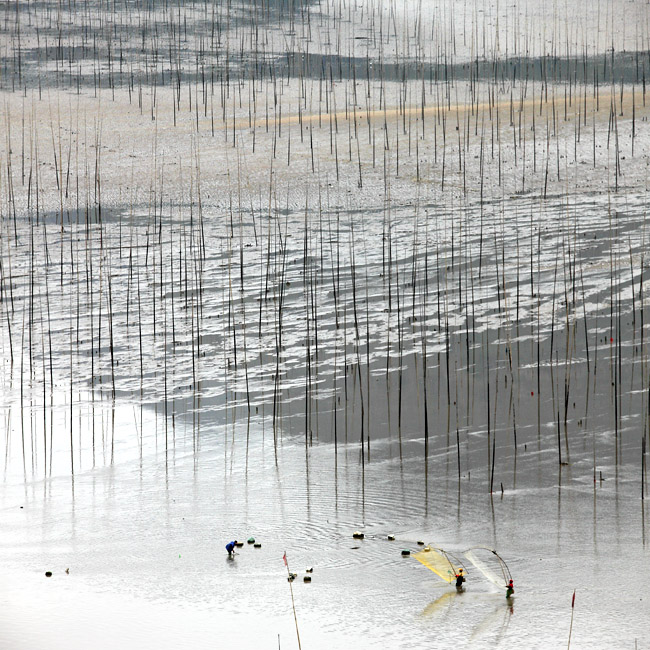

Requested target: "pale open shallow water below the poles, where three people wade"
[{"left": 2, "top": 420, "right": 650, "bottom": 648}]
